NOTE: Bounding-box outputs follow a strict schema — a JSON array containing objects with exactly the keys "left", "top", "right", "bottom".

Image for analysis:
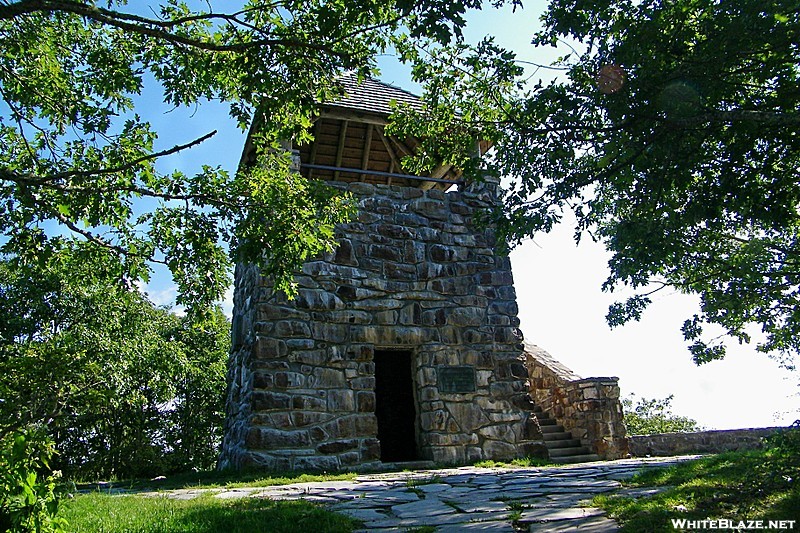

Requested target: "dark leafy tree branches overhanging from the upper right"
[{"left": 398, "top": 0, "right": 800, "bottom": 366}]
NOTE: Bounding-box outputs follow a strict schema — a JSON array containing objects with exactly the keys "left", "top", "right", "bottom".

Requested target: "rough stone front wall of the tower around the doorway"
[{"left": 220, "top": 179, "right": 546, "bottom": 470}]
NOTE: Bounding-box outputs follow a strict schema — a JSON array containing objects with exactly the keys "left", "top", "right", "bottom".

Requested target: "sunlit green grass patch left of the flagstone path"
[{"left": 61, "top": 493, "right": 360, "bottom": 533}]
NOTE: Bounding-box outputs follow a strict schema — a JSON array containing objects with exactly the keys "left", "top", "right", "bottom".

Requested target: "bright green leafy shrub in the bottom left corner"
[{"left": 0, "top": 428, "right": 67, "bottom": 533}]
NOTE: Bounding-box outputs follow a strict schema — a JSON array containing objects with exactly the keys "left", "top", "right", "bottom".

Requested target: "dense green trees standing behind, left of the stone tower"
[{"left": 0, "top": 240, "right": 229, "bottom": 477}]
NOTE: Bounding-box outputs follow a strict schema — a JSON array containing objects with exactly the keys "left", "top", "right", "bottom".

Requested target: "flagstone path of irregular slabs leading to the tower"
[{"left": 147, "top": 456, "right": 697, "bottom": 533}]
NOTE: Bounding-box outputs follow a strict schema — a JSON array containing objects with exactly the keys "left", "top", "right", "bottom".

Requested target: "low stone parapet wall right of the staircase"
[{"left": 628, "top": 427, "right": 786, "bottom": 457}]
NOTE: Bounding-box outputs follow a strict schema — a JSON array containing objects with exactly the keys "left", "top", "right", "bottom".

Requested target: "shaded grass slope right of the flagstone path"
[{"left": 592, "top": 448, "right": 800, "bottom": 532}]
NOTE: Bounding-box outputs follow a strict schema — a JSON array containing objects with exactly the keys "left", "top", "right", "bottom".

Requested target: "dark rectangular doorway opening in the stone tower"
[{"left": 375, "top": 350, "right": 419, "bottom": 462}]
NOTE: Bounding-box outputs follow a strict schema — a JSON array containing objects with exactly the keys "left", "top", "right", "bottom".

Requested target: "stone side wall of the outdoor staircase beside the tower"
[{"left": 525, "top": 345, "right": 628, "bottom": 459}]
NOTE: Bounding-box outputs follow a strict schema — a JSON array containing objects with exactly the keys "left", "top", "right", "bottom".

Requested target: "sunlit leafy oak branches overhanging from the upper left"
[{"left": 0, "top": 0, "right": 500, "bottom": 308}]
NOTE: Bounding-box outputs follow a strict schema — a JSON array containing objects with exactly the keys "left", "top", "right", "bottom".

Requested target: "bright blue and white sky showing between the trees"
[{"left": 138, "top": 2, "right": 800, "bottom": 429}]
